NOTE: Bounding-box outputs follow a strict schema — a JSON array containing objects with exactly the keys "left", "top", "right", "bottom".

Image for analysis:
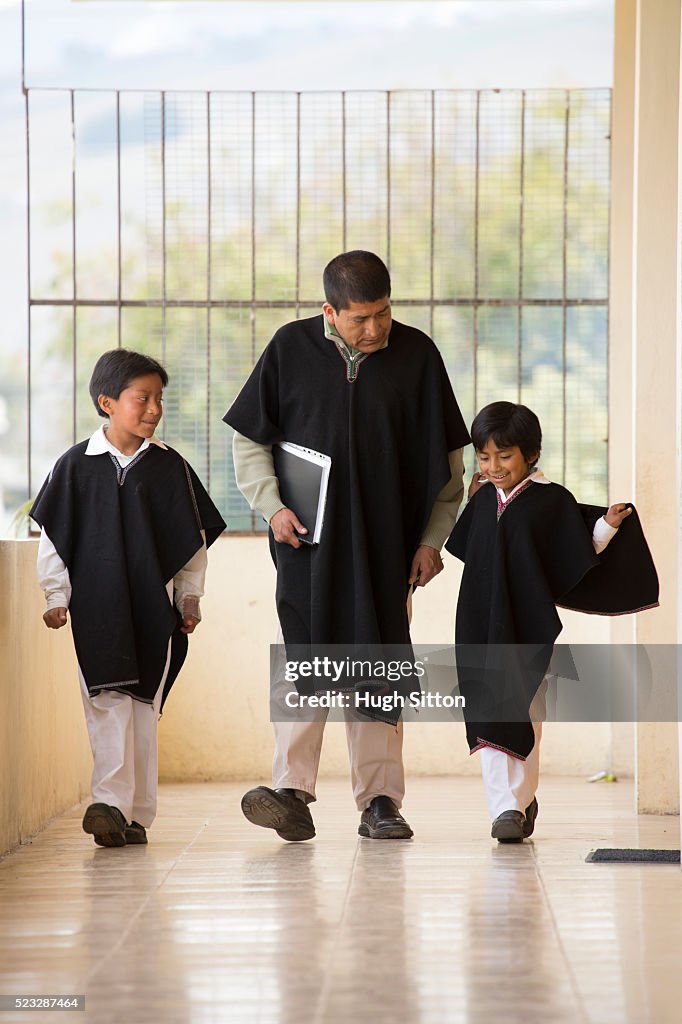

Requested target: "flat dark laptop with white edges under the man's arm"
[{"left": 272, "top": 441, "right": 332, "bottom": 544}]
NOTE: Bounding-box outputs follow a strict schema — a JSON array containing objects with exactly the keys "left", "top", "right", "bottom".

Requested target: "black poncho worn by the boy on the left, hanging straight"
[{"left": 31, "top": 441, "right": 225, "bottom": 703}]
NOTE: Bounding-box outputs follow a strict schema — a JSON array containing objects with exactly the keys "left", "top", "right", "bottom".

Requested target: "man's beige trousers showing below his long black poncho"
[{"left": 271, "top": 628, "right": 404, "bottom": 811}]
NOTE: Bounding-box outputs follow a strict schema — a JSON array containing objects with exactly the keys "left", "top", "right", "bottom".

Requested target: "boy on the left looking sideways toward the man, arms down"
[{"left": 31, "top": 349, "right": 225, "bottom": 847}]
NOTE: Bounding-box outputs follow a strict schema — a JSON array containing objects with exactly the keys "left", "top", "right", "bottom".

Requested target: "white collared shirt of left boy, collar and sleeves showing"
[{"left": 37, "top": 424, "right": 208, "bottom": 618}]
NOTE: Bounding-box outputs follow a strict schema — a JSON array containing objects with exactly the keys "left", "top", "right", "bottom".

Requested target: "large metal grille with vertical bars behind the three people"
[{"left": 27, "top": 89, "right": 610, "bottom": 531}]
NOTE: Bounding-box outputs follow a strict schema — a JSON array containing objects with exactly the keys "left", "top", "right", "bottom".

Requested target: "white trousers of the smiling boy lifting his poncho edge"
[{"left": 478, "top": 679, "right": 547, "bottom": 821}]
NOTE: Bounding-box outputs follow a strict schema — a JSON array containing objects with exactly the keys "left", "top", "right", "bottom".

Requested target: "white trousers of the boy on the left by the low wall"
[{"left": 78, "top": 641, "right": 170, "bottom": 828}]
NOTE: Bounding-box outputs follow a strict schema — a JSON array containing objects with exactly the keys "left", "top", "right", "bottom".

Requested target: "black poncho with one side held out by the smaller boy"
[{"left": 445, "top": 483, "right": 658, "bottom": 759}]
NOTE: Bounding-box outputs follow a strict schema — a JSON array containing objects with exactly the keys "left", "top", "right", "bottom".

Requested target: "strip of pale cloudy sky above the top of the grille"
[{"left": 14, "top": 0, "right": 612, "bottom": 90}]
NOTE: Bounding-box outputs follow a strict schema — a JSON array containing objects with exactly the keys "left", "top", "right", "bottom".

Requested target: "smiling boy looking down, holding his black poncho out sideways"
[{"left": 445, "top": 401, "right": 657, "bottom": 843}]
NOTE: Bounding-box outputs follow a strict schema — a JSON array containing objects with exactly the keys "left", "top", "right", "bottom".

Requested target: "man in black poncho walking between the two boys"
[{"left": 224, "top": 251, "right": 469, "bottom": 842}]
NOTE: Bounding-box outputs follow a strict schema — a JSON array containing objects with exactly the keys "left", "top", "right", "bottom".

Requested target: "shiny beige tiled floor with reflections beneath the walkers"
[{"left": 0, "top": 778, "right": 682, "bottom": 1024}]
